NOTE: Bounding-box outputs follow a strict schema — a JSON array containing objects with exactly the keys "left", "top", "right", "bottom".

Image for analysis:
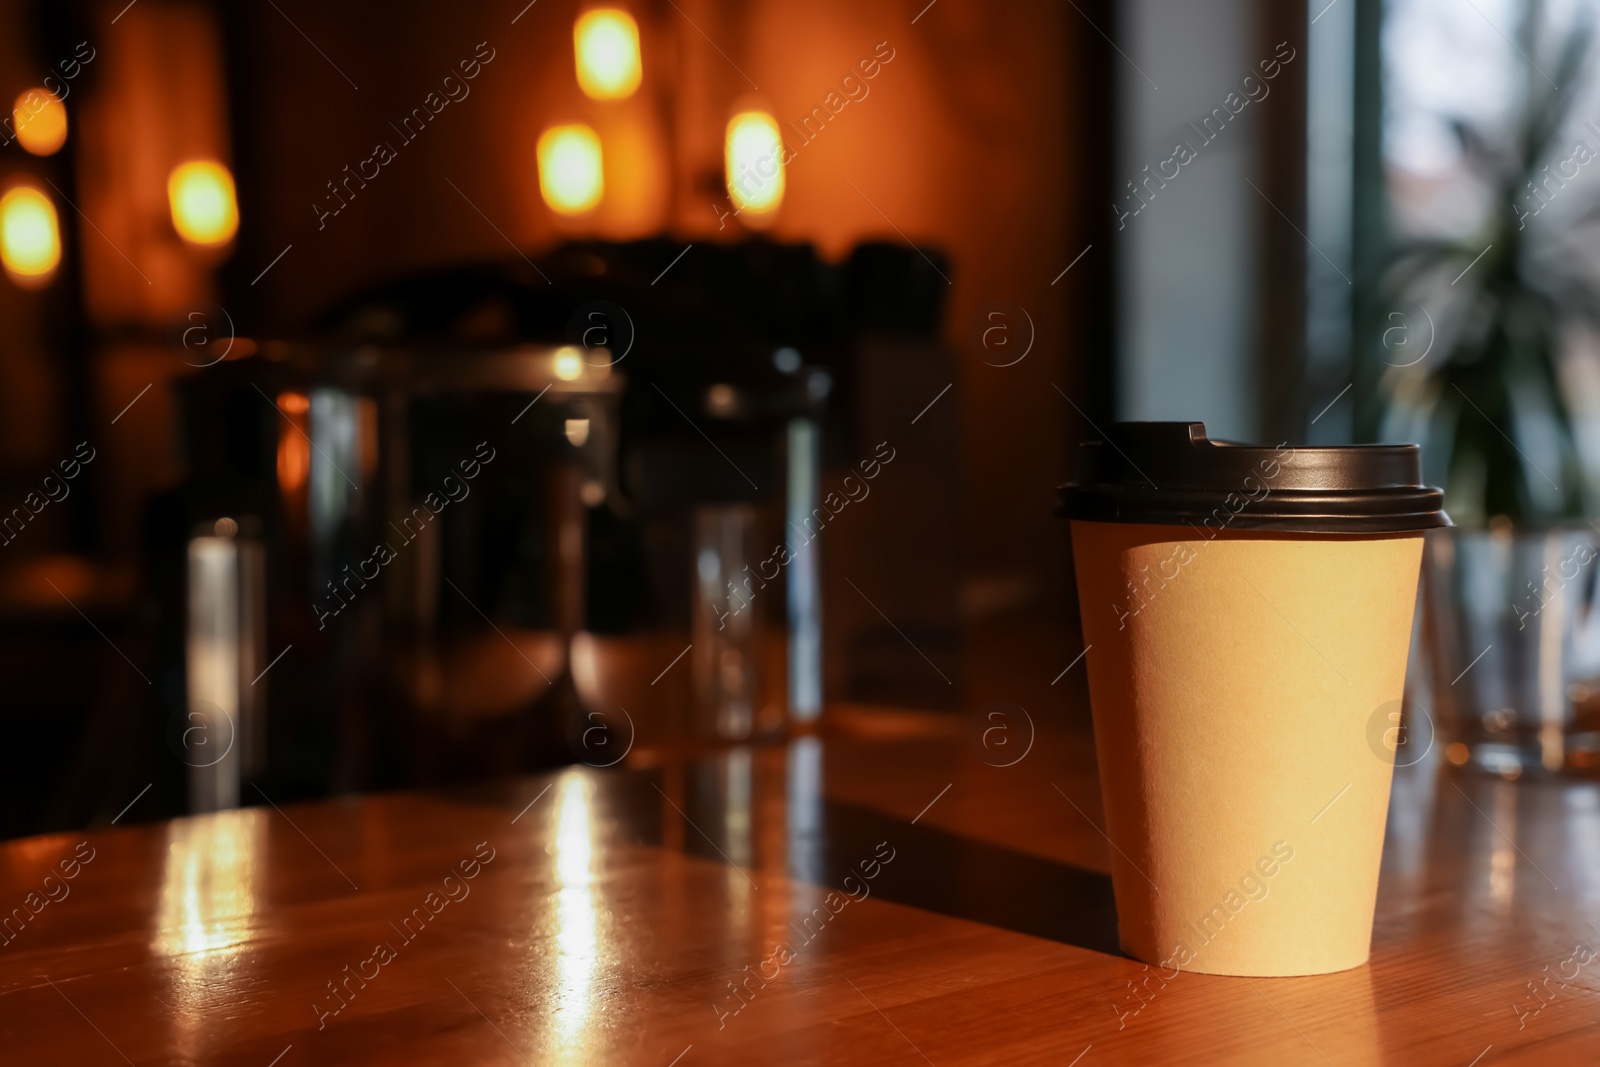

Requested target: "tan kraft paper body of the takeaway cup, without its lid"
[{"left": 1072, "top": 520, "right": 1422, "bottom": 976}]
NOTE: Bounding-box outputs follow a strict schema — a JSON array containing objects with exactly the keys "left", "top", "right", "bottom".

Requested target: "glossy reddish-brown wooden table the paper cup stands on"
[{"left": 0, "top": 712, "right": 1600, "bottom": 1067}]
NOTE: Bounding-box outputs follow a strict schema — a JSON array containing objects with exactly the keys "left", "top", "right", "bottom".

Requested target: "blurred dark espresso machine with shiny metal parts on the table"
[{"left": 166, "top": 240, "right": 936, "bottom": 809}]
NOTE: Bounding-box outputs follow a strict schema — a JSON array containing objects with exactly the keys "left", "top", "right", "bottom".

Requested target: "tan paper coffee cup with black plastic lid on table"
[{"left": 1062, "top": 422, "right": 1450, "bottom": 976}]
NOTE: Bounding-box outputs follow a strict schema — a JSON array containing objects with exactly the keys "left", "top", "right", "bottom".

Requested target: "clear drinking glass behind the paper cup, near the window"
[{"left": 1422, "top": 523, "right": 1600, "bottom": 777}]
